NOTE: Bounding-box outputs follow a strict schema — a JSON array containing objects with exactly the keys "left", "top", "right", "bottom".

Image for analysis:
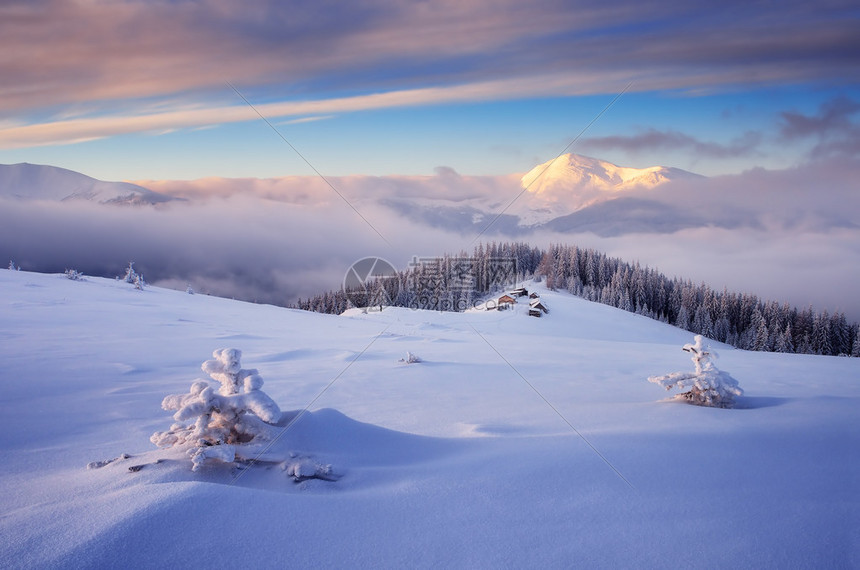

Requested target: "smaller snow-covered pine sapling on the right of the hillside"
[{"left": 648, "top": 335, "right": 744, "bottom": 408}]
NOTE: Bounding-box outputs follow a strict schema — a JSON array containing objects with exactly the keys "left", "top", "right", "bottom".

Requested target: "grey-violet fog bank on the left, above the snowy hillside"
[{"left": 0, "top": 191, "right": 470, "bottom": 305}]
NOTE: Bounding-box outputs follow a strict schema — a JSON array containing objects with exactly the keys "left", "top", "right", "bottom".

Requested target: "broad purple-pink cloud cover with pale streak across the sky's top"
[{"left": 0, "top": 0, "right": 860, "bottom": 146}]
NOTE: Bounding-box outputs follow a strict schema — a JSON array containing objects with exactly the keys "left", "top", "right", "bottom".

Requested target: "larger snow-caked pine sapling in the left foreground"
[{"left": 150, "top": 348, "right": 281, "bottom": 471}]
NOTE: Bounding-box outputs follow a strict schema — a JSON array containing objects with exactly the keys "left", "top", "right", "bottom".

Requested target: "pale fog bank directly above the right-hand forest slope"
[{"left": 564, "top": 227, "right": 860, "bottom": 322}]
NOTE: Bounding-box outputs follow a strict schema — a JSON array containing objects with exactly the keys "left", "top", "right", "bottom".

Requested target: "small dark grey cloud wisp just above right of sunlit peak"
[{"left": 581, "top": 128, "right": 762, "bottom": 159}]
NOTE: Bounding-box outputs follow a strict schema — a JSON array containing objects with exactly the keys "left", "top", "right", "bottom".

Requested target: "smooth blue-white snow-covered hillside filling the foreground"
[{"left": 0, "top": 270, "right": 860, "bottom": 568}]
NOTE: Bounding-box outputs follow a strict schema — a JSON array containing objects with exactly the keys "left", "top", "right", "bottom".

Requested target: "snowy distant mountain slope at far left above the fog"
[{"left": 0, "top": 162, "right": 174, "bottom": 204}]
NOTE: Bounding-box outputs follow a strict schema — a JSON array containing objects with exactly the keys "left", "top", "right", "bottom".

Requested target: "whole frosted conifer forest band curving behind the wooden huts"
[{"left": 295, "top": 242, "right": 860, "bottom": 356}]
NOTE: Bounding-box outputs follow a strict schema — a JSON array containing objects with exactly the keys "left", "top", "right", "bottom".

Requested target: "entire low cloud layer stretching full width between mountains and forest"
[{"left": 0, "top": 154, "right": 860, "bottom": 320}]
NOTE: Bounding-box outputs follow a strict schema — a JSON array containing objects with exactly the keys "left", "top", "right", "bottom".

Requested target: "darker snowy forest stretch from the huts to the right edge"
[{"left": 537, "top": 245, "right": 860, "bottom": 356}]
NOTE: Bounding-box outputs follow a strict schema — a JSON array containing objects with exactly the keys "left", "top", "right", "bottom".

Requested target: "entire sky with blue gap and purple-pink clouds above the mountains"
[{"left": 0, "top": 0, "right": 860, "bottom": 180}]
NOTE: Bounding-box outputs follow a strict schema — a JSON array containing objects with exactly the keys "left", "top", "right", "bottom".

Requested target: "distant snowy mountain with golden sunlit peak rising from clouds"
[{"left": 368, "top": 154, "right": 709, "bottom": 231}]
